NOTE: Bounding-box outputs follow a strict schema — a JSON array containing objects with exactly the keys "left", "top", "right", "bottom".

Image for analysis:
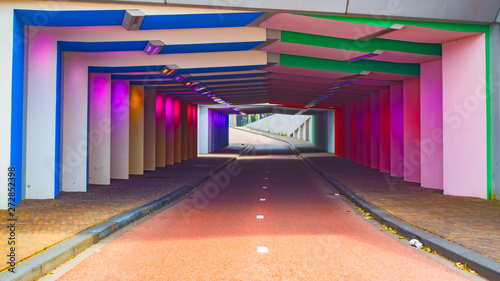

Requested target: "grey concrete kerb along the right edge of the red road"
[{"left": 234, "top": 128, "right": 500, "bottom": 280}]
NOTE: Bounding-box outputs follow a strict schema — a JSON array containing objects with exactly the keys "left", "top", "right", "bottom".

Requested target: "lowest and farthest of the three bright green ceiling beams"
[{"left": 280, "top": 54, "right": 420, "bottom": 76}]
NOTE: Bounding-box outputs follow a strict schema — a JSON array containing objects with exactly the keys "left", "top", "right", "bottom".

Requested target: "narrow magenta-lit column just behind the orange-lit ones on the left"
[{"left": 155, "top": 93, "right": 167, "bottom": 168}]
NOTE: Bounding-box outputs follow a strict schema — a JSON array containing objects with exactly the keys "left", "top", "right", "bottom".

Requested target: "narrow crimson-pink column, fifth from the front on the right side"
[{"left": 379, "top": 89, "right": 391, "bottom": 173}]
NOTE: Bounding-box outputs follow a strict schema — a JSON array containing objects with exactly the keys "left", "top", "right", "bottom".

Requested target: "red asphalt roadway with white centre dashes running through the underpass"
[{"left": 59, "top": 131, "right": 468, "bottom": 281}]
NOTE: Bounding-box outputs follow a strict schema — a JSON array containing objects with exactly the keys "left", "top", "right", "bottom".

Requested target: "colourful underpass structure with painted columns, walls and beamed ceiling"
[{"left": 0, "top": 1, "right": 499, "bottom": 209}]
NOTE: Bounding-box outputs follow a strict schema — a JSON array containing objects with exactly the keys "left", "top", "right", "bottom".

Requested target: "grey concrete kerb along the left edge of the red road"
[{"left": 0, "top": 144, "right": 253, "bottom": 281}]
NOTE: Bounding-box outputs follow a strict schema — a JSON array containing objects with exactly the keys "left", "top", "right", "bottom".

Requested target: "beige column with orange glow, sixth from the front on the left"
[{"left": 144, "top": 90, "right": 156, "bottom": 171}]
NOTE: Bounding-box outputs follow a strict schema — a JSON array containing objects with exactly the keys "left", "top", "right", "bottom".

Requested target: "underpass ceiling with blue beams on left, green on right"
[{"left": 24, "top": 4, "right": 488, "bottom": 111}]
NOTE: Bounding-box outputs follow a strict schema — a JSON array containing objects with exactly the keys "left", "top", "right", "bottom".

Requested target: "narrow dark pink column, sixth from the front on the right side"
[{"left": 370, "top": 93, "right": 380, "bottom": 169}]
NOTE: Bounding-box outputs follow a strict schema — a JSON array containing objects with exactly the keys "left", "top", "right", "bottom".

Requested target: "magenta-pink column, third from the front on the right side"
[{"left": 403, "top": 79, "right": 420, "bottom": 182}]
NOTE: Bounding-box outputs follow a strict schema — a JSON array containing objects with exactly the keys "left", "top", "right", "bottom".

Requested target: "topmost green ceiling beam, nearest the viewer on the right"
[{"left": 298, "top": 14, "right": 489, "bottom": 33}]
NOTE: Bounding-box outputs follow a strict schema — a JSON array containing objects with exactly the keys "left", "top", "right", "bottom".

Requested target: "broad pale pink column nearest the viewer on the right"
[{"left": 442, "top": 34, "right": 488, "bottom": 198}]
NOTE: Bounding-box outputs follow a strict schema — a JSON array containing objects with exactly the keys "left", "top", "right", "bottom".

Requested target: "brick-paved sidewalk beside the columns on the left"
[{"left": 0, "top": 143, "right": 247, "bottom": 270}]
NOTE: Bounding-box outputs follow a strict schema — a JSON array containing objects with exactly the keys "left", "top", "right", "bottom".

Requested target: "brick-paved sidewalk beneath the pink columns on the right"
[{"left": 241, "top": 130, "right": 500, "bottom": 261}]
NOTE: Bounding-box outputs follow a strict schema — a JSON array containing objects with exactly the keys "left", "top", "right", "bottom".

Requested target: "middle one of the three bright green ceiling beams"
[{"left": 281, "top": 31, "right": 442, "bottom": 55}]
